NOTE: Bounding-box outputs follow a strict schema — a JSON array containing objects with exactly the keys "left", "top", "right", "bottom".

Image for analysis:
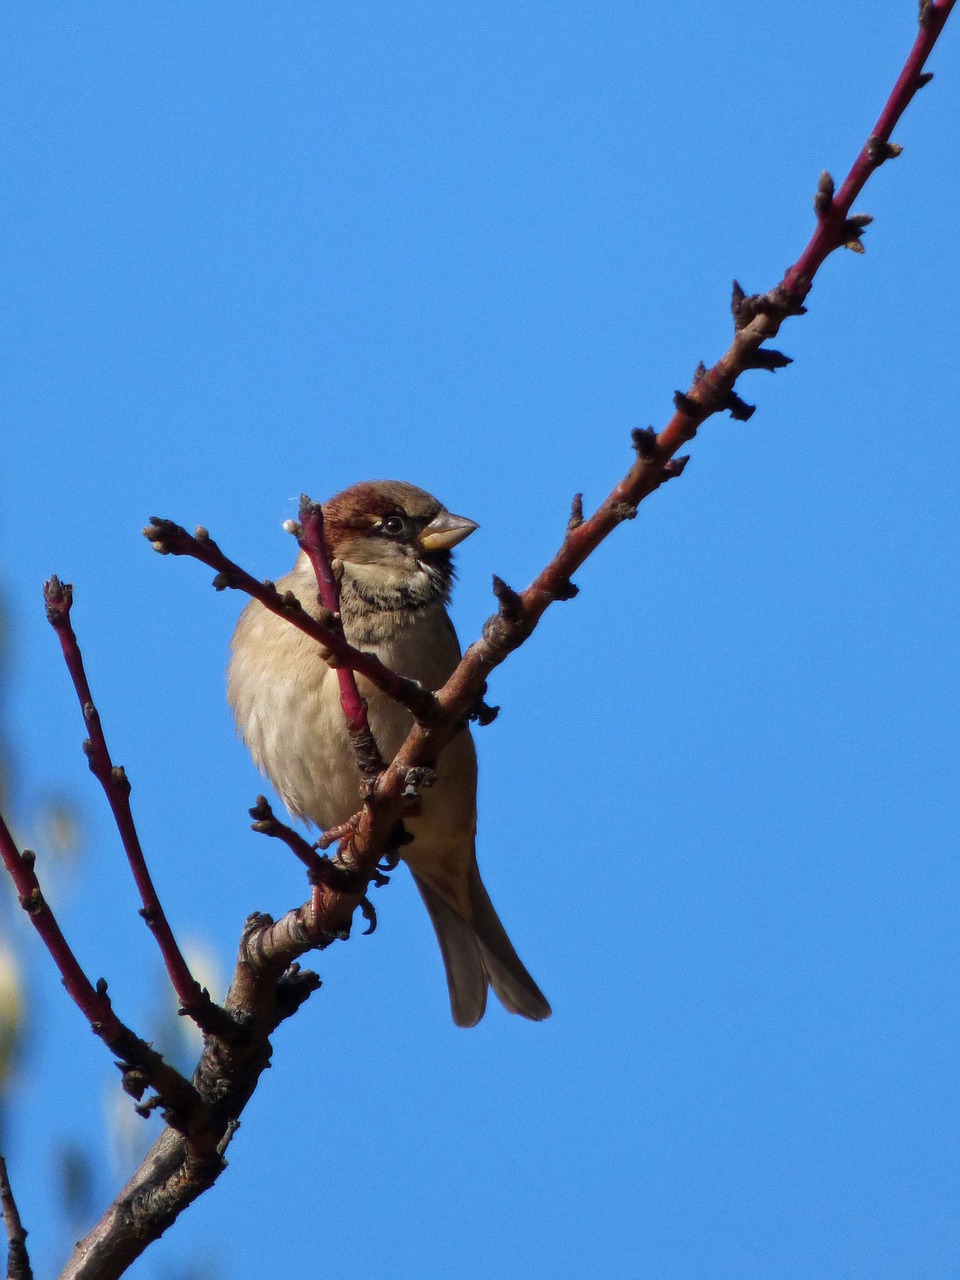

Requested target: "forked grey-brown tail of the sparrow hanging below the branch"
[{"left": 413, "top": 863, "right": 550, "bottom": 1027}]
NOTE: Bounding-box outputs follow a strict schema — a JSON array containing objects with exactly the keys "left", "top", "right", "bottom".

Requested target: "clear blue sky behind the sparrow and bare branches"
[{"left": 0, "top": 0, "right": 960, "bottom": 1280}]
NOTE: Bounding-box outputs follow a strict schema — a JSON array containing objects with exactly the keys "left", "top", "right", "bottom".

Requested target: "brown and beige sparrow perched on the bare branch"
[{"left": 227, "top": 480, "right": 550, "bottom": 1027}]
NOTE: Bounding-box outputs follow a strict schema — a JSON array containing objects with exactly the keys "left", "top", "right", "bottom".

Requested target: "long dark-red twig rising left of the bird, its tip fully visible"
[{"left": 44, "top": 576, "right": 229, "bottom": 1030}]
